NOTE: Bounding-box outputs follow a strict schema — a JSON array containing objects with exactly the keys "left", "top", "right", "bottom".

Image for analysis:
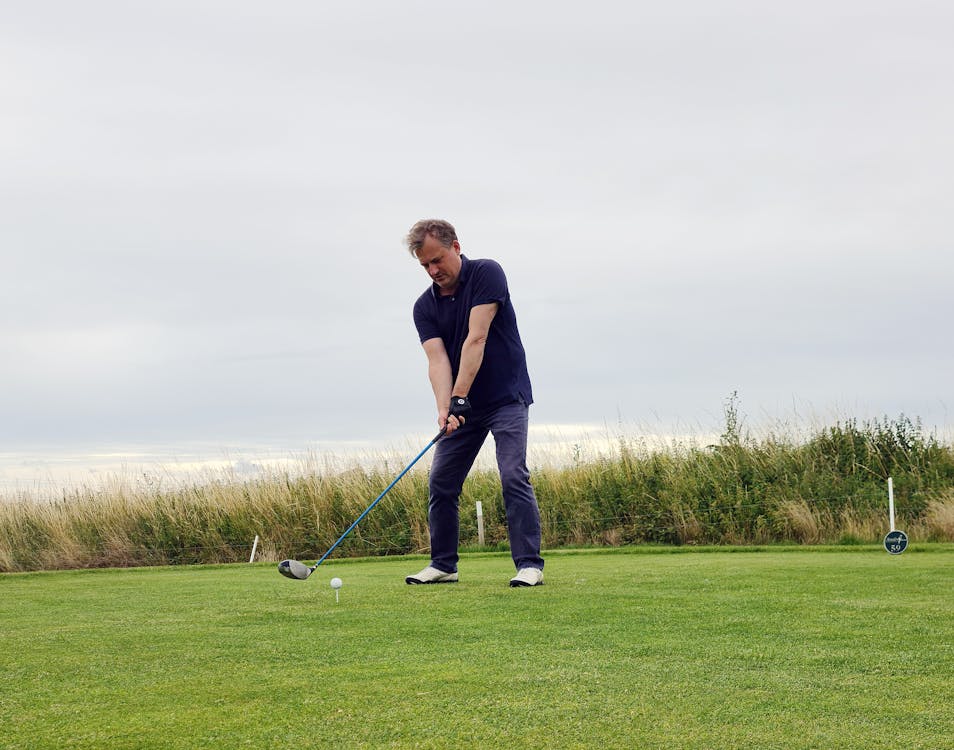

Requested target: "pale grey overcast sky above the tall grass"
[{"left": 0, "top": 0, "right": 954, "bottom": 489}]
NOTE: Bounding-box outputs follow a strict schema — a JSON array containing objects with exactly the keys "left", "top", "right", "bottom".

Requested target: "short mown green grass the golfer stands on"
[{"left": 0, "top": 545, "right": 954, "bottom": 750}]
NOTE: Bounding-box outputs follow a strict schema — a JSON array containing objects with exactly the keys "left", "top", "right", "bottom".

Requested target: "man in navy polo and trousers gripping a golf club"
[{"left": 405, "top": 219, "right": 543, "bottom": 587}]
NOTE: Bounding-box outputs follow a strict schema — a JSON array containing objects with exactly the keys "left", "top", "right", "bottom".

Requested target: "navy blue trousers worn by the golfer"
[{"left": 427, "top": 402, "right": 543, "bottom": 573}]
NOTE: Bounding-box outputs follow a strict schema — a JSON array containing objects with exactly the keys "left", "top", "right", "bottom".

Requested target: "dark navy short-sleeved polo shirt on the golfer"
[{"left": 414, "top": 255, "right": 533, "bottom": 412}]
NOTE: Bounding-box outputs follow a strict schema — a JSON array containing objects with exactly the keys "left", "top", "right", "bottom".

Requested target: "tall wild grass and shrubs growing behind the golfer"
[{"left": 0, "top": 412, "right": 954, "bottom": 572}]
